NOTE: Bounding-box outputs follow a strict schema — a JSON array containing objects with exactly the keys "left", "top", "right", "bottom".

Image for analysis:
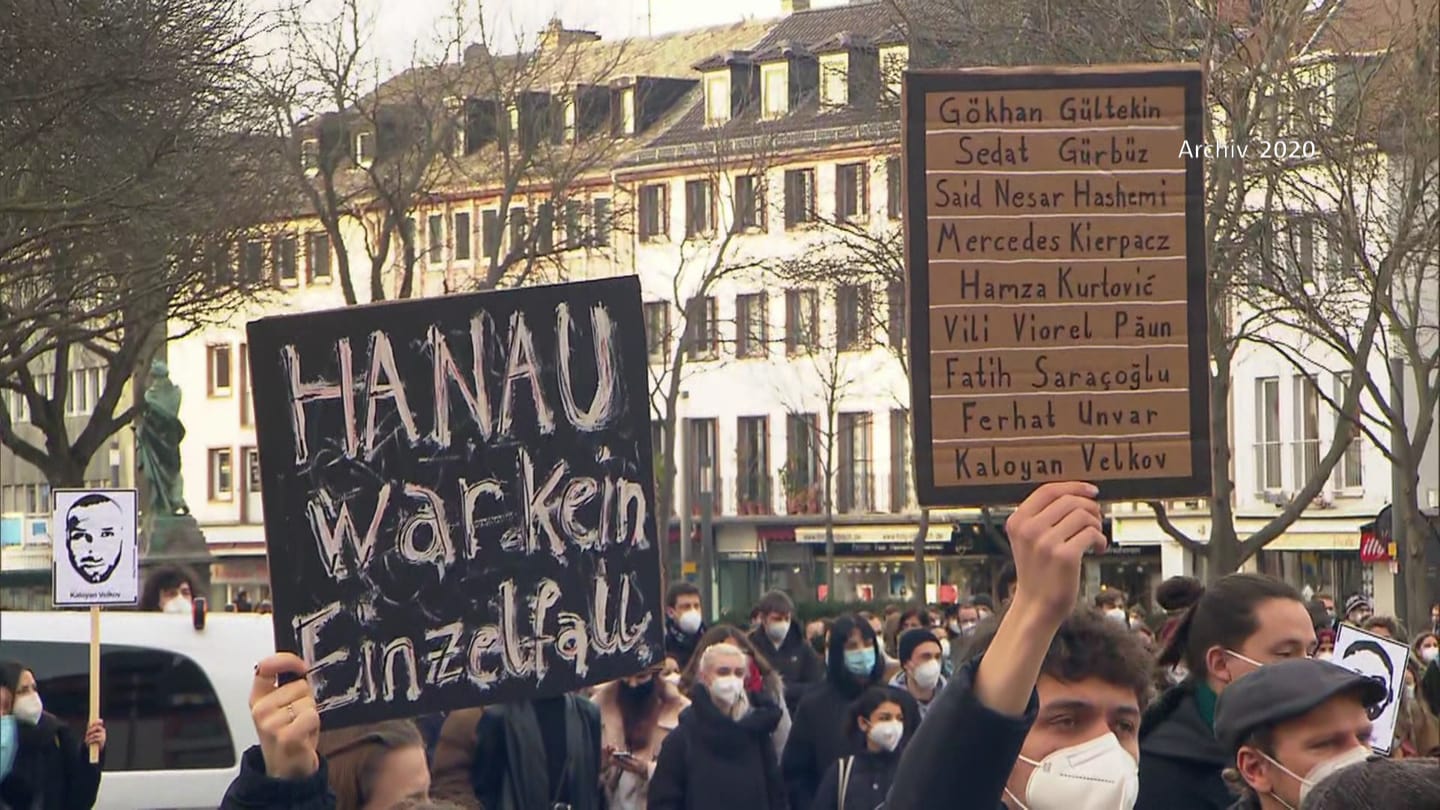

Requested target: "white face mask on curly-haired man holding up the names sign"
[{"left": 1005, "top": 732, "right": 1140, "bottom": 810}]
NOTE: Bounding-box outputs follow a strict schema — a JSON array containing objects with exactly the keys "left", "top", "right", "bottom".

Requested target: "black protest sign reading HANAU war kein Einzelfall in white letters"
[{"left": 249, "top": 278, "right": 664, "bottom": 728}]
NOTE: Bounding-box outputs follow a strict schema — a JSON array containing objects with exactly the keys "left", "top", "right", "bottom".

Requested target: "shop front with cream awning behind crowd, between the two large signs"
[{"left": 795, "top": 523, "right": 981, "bottom": 602}]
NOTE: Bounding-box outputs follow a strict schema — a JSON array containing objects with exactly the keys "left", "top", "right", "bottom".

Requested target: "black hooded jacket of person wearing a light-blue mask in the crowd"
[{"left": 780, "top": 615, "right": 920, "bottom": 810}]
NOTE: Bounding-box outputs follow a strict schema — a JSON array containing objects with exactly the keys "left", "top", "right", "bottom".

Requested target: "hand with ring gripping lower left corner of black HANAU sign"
[{"left": 251, "top": 653, "right": 320, "bottom": 780}]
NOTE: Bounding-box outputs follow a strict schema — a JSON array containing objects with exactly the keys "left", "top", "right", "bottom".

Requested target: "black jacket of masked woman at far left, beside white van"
[{"left": 0, "top": 712, "right": 105, "bottom": 810}]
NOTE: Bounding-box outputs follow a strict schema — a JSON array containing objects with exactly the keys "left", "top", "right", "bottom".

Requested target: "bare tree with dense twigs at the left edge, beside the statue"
[{"left": 0, "top": 0, "right": 283, "bottom": 486}]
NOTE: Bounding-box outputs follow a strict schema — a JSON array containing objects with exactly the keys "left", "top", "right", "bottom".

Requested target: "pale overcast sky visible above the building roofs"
[{"left": 251, "top": 0, "right": 847, "bottom": 71}]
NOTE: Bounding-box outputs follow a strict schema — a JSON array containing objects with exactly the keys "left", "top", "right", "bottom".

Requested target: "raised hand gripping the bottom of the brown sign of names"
[{"left": 1005, "top": 481, "right": 1106, "bottom": 627}]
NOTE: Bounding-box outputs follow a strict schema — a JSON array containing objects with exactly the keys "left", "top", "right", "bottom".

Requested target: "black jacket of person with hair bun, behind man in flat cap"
[{"left": 1135, "top": 682, "right": 1236, "bottom": 810}]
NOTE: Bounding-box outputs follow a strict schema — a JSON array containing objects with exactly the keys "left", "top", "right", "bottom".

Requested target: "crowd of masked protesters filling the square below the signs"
[{"left": 0, "top": 483, "right": 1440, "bottom": 810}]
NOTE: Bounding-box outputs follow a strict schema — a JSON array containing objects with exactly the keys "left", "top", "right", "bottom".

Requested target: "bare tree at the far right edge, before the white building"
[{"left": 1232, "top": 0, "right": 1440, "bottom": 621}]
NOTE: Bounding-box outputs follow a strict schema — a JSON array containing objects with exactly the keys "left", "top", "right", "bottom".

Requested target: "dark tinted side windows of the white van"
[{"left": 4, "top": 641, "right": 235, "bottom": 771}]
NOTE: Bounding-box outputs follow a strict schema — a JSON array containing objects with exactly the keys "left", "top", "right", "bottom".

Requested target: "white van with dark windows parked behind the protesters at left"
[{"left": 0, "top": 610, "right": 275, "bottom": 810}]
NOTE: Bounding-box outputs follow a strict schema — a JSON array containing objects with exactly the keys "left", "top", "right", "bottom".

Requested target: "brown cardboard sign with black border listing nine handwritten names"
[{"left": 903, "top": 65, "right": 1211, "bottom": 506}]
